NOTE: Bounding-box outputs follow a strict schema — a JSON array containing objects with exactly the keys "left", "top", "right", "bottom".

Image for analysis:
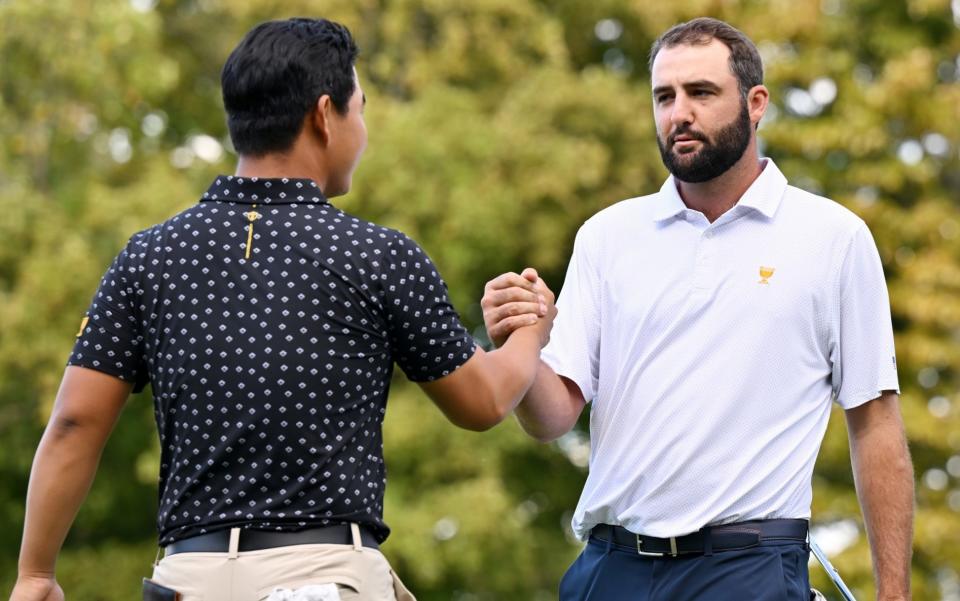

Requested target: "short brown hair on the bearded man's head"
[{"left": 648, "top": 17, "right": 763, "bottom": 98}]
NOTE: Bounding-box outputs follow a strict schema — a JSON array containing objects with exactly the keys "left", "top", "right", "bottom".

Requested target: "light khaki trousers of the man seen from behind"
[{"left": 152, "top": 527, "right": 416, "bottom": 601}]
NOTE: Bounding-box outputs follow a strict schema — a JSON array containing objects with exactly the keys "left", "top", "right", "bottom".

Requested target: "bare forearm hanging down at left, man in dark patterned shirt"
[{"left": 19, "top": 420, "right": 109, "bottom": 575}]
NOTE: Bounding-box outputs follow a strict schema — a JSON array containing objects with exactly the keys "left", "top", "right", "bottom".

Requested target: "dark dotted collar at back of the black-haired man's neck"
[{"left": 201, "top": 175, "right": 327, "bottom": 205}]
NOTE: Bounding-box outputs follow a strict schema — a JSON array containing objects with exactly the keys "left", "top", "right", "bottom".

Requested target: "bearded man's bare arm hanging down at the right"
[{"left": 846, "top": 391, "right": 914, "bottom": 601}]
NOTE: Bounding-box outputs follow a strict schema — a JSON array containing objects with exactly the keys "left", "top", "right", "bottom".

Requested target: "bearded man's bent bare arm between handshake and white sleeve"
[{"left": 515, "top": 361, "right": 584, "bottom": 442}]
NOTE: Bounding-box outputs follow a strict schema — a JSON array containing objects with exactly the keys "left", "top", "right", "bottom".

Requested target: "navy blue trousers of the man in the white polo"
[{"left": 560, "top": 538, "right": 810, "bottom": 601}]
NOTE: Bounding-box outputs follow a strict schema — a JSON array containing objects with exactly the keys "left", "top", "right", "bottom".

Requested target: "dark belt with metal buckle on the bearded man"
[{"left": 590, "top": 520, "right": 808, "bottom": 557}]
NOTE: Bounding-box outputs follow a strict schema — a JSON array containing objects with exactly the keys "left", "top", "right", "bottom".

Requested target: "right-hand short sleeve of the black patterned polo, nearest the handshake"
[{"left": 383, "top": 233, "right": 476, "bottom": 382}]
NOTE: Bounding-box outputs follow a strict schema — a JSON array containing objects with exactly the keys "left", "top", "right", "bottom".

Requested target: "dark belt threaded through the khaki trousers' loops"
[{"left": 164, "top": 524, "right": 380, "bottom": 555}]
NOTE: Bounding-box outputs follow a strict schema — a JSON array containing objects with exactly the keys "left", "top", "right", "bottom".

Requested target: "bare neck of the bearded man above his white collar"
[{"left": 677, "top": 138, "right": 763, "bottom": 223}]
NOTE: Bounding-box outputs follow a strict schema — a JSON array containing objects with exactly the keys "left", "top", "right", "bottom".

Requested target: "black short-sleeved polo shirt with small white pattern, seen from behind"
[{"left": 68, "top": 176, "right": 475, "bottom": 545}]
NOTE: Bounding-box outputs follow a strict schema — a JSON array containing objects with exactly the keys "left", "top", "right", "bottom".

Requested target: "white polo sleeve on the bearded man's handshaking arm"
[{"left": 540, "top": 227, "right": 600, "bottom": 402}]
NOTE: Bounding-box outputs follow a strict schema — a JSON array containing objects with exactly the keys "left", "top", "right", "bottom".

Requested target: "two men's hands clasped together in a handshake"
[{"left": 480, "top": 267, "right": 557, "bottom": 347}]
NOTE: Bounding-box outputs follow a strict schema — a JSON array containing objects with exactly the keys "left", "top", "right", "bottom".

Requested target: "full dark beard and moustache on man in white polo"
[{"left": 657, "top": 102, "right": 750, "bottom": 184}]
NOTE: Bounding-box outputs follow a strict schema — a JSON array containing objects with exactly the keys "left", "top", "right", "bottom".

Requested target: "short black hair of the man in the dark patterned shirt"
[{"left": 220, "top": 18, "right": 357, "bottom": 156}]
